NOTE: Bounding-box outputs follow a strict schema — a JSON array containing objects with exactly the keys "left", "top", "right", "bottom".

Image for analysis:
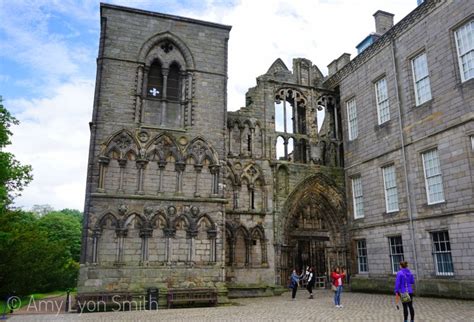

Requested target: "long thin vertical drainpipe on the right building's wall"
[{"left": 391, "top": 40, "right": 420, "bottom": 280}]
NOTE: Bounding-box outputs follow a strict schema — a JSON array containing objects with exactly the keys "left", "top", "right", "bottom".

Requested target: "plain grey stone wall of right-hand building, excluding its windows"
[{"left": 325, "top": 1, "right": 474, "bottom": 298}]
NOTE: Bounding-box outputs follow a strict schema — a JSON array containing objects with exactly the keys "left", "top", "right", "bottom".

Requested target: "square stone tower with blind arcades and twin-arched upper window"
[{"left": 78, "top": 4, "right": 230, "bottom": 300}]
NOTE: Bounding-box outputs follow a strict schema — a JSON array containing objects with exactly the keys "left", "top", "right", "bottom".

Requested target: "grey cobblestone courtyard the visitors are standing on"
[{"left": 9, "top": 290, "right": 474, "bottom": 322}]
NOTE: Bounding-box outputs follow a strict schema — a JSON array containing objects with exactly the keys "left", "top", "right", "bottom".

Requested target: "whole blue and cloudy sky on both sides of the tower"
[{"left": 0, "top": 0, "right": 416, "bottom": 210}]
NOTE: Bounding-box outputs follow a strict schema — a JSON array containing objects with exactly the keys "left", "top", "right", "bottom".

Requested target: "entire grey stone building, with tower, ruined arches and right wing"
[{"left": 78, "top": 0, "right": 474, "bottom": 302}]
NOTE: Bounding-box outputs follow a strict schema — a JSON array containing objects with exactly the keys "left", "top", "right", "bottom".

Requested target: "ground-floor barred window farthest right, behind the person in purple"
[{"left": 431, "top": 230, "right": 454, "bottom": 276}]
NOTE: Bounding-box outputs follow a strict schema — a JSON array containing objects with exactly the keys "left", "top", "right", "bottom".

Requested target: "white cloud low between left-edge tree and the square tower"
[{"left": 4, "top": 80, "right": 94, "bottom": 209}]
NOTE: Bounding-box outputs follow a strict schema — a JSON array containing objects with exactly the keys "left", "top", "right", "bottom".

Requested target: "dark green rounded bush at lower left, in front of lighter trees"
[{"left": 0, "top": 210, "right": 71, "bottom": 295}]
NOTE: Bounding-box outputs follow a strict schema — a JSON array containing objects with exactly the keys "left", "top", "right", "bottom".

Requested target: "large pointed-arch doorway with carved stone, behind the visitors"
[{"left": 277, "top": 173, "right": 347, "bottom": 286}]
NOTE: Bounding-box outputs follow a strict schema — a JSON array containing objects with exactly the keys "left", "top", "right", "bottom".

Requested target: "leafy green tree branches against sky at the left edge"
[{"left": 0, "top": 96, "right": 32, "bottom": 210}]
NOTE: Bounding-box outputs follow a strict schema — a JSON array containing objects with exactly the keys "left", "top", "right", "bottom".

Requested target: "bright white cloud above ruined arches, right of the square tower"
[{"left": 180, "top": 0, "right": 416, "bottom": 110}]
